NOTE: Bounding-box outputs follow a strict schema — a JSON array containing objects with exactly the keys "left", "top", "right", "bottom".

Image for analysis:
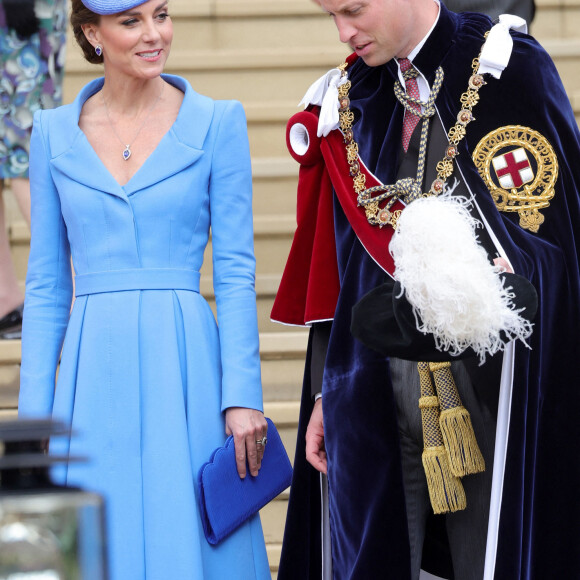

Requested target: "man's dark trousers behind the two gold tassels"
[{"left": 391, "top": 358, "right": 497, "bottom": 580}]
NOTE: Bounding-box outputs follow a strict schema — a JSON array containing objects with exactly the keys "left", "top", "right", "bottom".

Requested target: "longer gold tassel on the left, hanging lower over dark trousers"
[{"left": 417, "top": 363, "right": 467, "bottom": 514}]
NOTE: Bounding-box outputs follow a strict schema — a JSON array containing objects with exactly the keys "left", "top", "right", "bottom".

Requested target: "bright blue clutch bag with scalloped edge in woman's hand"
[{"left": 198, "top": 418, "right": 292, "bottom": 544}]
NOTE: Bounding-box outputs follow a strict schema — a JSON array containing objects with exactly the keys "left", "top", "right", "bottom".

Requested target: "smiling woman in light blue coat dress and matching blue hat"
[{"left": 19, "top": 0, "right": 270, "bottom": 580}]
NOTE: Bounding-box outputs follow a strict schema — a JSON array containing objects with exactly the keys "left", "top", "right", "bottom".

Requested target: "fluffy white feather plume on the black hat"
[{"left": 390, "top": 194, "right": 532, "bottom": 362}]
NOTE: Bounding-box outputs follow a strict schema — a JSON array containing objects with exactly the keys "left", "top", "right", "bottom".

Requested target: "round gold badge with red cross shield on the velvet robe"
[{"left": 472, "top": 125, "right": 558, "bottom": 232}]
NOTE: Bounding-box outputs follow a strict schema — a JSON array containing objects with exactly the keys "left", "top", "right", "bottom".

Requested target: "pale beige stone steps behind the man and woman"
[{"left": 0, "top": 0, "right": 580, "bottom": 578}]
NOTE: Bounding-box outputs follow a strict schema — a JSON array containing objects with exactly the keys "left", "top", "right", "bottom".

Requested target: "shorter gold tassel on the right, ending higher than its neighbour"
[{"left": 429, "top": 362, "right": 485, "bottom": 477}]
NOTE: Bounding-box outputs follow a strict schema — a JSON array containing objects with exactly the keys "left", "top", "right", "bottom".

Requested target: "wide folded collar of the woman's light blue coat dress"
[{"left": 50, "top": 75, "right": 214, "bottom": 199}]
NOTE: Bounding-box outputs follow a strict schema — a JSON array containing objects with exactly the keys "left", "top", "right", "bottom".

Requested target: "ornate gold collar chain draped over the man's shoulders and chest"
[{"left": 338, "top": 49, "right": 487, "bottom": 228}]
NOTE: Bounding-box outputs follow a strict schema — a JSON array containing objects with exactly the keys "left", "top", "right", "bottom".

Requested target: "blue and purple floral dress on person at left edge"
[{"left": 0, "top": 0, "right": 67, "bottom": 178}]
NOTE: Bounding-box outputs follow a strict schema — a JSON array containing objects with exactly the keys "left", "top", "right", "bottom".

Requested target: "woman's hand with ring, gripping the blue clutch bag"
[{"left": 226, "top": 407, "right": 268, "bottom": 479}]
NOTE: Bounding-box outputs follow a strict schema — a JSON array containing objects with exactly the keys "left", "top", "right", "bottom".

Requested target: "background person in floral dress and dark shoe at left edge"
[{"left": 0, "top": 0, "right": 66, "bottom": 339}]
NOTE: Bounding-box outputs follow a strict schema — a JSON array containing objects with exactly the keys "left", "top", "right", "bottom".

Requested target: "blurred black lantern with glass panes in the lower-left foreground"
[{"left": 0, "top": 420, "right": 108, "bottom": 580}]
